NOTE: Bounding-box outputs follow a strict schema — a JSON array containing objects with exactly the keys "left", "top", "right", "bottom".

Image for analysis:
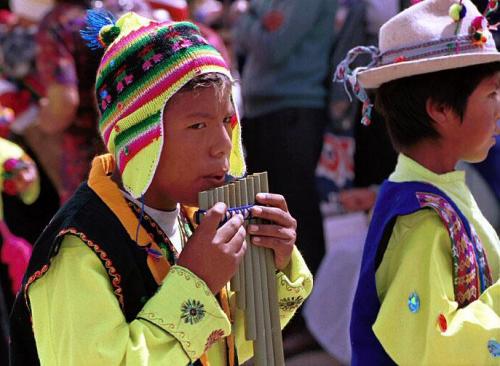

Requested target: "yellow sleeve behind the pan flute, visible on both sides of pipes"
[{"left": 230, "top": 247, "right": 313, "bottom": 364}]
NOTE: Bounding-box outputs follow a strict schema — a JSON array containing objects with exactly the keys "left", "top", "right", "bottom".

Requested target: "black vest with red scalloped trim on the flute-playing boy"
[{"left": 10, "top": 183, "right": 158, "bottom": 366}]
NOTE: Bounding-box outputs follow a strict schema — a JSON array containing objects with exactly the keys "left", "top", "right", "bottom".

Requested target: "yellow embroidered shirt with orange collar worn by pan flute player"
[{"left": 27, "top": 157, "right": 312, "bottom": 366}]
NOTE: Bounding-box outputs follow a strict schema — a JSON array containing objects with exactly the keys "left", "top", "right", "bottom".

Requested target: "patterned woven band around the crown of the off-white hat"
[{"left": 376, "top": 35, "right": 497, "bottom": 67}]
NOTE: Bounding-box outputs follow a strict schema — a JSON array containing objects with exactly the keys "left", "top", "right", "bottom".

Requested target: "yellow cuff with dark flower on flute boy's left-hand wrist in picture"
[{"left": 137, "top": 266, "right": 231, "bottom": 361}]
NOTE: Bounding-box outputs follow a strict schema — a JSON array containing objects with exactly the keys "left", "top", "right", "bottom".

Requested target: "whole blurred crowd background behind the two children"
[{"left": 0, "top": 0, "right": 500, "bottom": 365}]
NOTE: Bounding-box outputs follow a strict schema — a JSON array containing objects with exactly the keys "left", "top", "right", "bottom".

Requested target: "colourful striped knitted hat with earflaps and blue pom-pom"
[{"left": 82, "top": 10, "right": 245, "bottom": 198}]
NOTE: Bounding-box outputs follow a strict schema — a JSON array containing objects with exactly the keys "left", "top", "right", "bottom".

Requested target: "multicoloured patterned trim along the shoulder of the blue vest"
[{"left": 416, "top": 192, "right": 492, "bottom": 307}]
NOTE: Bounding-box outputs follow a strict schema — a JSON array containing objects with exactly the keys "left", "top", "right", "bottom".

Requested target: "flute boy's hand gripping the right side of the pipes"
[{"left": 248, "top": 193, "right": 297, "bottom": 270}]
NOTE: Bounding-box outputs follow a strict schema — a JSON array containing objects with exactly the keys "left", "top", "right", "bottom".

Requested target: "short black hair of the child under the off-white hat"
[{"left": 375, "top": 62, "right": 500, "bottom": 151}]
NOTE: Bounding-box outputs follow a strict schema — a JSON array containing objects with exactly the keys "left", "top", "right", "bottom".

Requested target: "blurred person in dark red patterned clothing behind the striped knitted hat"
[{"left": 36, "top": 0, "right": 105, "bottom": 202}]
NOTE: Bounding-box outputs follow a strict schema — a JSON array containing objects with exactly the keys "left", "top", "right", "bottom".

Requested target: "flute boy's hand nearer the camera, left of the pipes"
[{"left": 177, "top": 203, "right": 246, "bottom": 294}]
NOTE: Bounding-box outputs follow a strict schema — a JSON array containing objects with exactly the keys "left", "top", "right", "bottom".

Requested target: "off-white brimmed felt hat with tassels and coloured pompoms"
[{"left": 334, "top": 0, "right": 500, "bottom": 125}]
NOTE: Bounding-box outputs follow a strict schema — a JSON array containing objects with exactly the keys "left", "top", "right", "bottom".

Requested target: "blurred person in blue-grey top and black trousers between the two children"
[{"left": 234, "top": 0, "right": 337, "bottom": 286}]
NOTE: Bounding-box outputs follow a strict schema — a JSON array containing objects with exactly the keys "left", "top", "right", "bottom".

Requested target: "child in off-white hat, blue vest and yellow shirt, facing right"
[{"left": 336, "top": 0, "right": 500, "bottom": 365}]
